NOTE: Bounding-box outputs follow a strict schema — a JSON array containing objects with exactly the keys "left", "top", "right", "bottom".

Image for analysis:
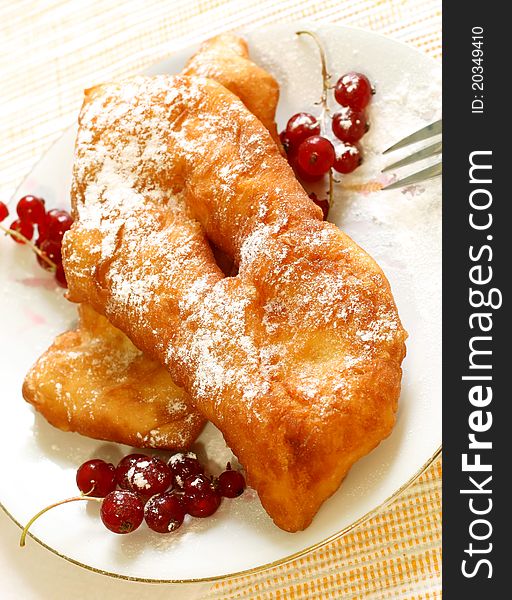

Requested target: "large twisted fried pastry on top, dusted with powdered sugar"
[{"left": 63, "top": 76, "right": 406, "bottom": 531}]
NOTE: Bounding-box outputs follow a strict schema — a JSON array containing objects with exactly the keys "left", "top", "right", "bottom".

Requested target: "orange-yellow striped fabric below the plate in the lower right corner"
[{"left": 203, "top": 460, "right": 441, "bottom": 600}]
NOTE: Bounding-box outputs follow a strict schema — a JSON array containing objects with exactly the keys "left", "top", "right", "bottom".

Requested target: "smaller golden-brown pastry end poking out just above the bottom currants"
[{"left": 23, "top": 305, "right": 205, "bottom": 449}]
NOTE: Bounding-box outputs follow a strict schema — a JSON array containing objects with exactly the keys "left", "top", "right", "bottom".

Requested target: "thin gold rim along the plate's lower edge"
[{"left": 0, "top": 446, "right": 442, "bottom": 583}]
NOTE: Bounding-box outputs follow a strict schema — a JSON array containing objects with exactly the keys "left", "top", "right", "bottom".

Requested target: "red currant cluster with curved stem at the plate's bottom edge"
[{"left": 21, "top": 452, "right": 245, "bottom": 545}]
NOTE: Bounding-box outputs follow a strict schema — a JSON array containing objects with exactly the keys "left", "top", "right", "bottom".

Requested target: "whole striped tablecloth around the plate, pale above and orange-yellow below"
[{"left": 0, "top": 0, "right": 441, "bottom": 600}]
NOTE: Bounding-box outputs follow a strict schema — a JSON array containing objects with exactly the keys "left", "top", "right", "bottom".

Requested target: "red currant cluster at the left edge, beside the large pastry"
[{"left": 0, "top": 195, "right": 73, "bottom": 288}]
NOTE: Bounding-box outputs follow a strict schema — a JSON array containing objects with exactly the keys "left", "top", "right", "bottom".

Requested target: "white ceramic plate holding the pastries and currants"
[{"left": 0, "top": 24, "right": 441, "bottom": 581}]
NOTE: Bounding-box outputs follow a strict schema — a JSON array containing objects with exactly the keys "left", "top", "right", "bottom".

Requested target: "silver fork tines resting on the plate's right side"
[{"left": 382, "top": 120, "right": 443, "bottom": 190}]
